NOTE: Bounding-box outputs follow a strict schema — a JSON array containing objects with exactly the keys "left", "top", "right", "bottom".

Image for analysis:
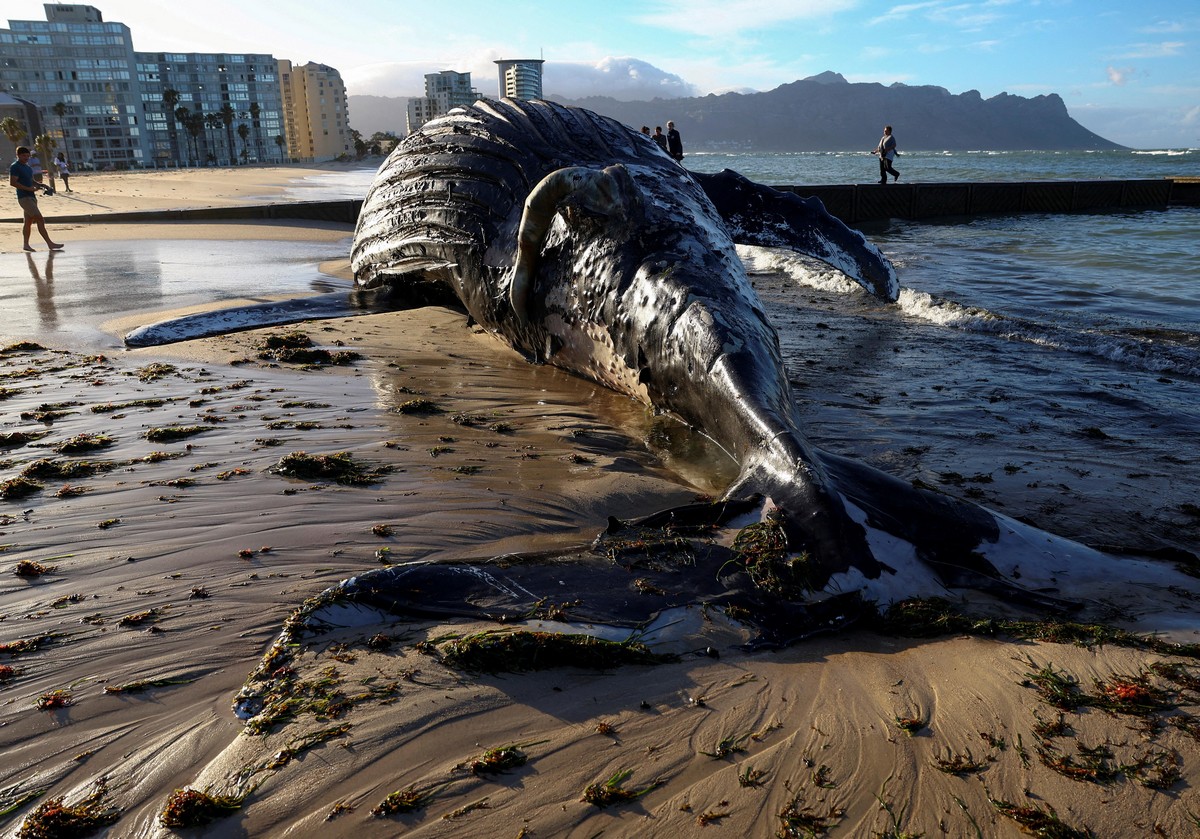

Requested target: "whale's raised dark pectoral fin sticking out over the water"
[{"left": 692, "top": 169, "right": 900, "bottom": 302}]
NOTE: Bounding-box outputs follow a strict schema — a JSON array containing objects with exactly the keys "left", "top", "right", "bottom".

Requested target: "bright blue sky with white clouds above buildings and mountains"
[{"left": 21, "top": 0, "right": 1200, "bottom": 149}]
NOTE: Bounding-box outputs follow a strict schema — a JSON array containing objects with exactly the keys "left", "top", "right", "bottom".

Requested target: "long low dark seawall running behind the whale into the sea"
[{"left": 11, "top": 178, "right": 1200, "bottom": 224}]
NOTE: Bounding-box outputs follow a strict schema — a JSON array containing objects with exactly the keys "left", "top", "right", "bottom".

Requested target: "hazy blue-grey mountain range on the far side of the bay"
[{"left": 349, "top": 72, "right": 1124, "bottom": 151}]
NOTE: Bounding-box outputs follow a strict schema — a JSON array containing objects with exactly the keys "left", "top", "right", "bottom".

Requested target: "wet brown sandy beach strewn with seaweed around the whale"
[{"left": 0, "top": 167, "right": 1200, "bottom": 839}]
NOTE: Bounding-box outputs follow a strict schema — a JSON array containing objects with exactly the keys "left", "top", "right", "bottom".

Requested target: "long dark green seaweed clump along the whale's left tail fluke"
[{"left": 429, "top": 630, "right": 678, "bottom": 673}]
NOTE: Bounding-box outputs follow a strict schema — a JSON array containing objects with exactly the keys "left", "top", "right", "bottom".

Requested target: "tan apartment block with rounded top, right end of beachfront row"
[{"left": 278, "top": 59, "right": 354, "bottom": 160}]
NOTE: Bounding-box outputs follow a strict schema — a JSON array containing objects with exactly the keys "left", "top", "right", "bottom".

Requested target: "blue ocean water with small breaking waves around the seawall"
[{"left": 220, "top": 151, "right": 1200, "bottom": 552}]
